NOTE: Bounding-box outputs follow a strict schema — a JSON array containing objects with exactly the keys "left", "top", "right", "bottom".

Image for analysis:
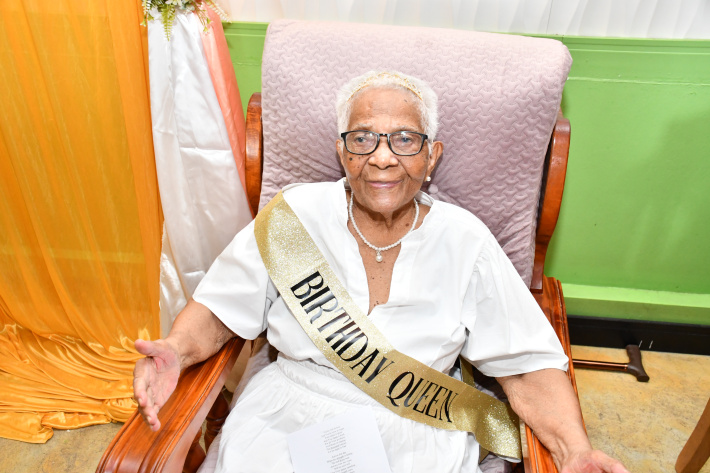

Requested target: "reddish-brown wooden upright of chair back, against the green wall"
[{"left": 530, "top": 111, "right": 570, "bottom": 293}]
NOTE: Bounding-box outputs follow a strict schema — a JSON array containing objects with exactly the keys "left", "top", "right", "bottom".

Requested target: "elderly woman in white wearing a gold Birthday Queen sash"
[{"left": 134, "top": 72, "right": 626, "bottom": 473}]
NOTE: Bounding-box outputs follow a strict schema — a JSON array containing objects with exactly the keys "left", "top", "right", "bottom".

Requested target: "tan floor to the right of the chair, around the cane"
[{"left": 572, "top": 346, "right": 710, "bottom": 473}]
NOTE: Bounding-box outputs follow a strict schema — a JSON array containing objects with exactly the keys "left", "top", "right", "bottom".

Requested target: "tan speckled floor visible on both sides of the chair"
[{"left": 0, "top": 346, "right": 710, "bottom": 473}]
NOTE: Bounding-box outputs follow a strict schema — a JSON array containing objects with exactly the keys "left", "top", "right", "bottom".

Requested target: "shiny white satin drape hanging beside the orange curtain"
[{"left": 148, "top": 14, "right": 251, "bottom": 336}]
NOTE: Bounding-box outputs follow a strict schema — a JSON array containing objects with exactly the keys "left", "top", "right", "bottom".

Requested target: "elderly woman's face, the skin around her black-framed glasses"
[{"left": 337, "top": 88, "right": 443, "bottom": 215}]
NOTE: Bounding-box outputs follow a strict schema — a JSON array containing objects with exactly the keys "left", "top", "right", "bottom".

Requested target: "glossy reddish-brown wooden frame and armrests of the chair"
[{"left": 96, "top": 94, "right": 577, "bottom": 473}]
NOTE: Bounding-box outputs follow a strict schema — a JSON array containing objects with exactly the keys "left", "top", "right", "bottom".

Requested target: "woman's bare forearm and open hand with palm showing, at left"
[{"left": 133, "top": 300, "right": 234, "bottom": 431}]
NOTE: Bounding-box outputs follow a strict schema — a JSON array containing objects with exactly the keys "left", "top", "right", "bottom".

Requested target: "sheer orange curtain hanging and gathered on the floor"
[{"left": 0, "top": 0, "right": 161, "bottom": 443}]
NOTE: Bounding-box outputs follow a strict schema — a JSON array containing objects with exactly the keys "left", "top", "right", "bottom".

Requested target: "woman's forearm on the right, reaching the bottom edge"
[{"left": 497, "top": 369, "right": 628, "bottom": 473}]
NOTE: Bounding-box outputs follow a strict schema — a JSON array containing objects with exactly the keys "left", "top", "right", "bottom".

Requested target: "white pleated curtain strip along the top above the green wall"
[{"left": 219, "top": 0, "right": 710, "bottom": 39}]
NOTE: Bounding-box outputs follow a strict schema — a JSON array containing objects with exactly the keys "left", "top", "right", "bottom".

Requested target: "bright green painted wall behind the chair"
[{"left": 224, "top": 23, "right": 710, "bottom": 325}]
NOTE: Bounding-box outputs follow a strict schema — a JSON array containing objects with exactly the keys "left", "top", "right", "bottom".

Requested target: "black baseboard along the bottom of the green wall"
[{"left": 567, "top": 315, "right": 710, "bottom": 356}]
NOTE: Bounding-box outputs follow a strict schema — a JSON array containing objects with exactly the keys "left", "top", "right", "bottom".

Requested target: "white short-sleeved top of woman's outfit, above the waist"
[{"left": 193, "top": 181, "right": 568, "bottom": 377}]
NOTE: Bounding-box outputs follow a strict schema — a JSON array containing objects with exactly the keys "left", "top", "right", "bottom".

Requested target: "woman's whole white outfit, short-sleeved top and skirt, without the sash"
[{"left": 193, "top": 181, "right": 568, "bottom": 473}]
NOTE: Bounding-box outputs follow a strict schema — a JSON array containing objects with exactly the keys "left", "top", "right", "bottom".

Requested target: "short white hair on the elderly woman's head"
[{"left": 335, "top": 71, "right": 439, "bottom": 142}]
